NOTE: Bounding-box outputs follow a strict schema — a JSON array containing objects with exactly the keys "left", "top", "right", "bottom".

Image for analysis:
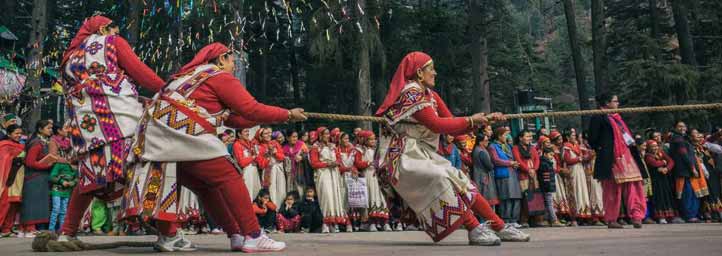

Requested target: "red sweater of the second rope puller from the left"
[{"left": 189, "top": 72, "right": 288, "bottom": 124}]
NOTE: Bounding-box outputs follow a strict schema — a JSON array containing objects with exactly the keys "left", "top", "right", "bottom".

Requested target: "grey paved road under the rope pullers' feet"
[{"left": 0, "top": 223, "right": 722, "bottom": 256}]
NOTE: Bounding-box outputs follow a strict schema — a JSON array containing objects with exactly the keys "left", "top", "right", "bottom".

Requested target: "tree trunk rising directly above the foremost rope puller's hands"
[{"left": 467, "top": 0, "right": 491, "bottom": 113}]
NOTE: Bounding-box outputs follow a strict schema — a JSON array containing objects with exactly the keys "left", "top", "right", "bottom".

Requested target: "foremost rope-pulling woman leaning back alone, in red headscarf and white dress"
[{"left": 376, "top": 52, "right": 529, "bottom": 245}]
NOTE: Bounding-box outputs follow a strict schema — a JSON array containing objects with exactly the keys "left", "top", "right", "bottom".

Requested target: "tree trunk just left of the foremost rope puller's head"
[{"left": 351, "top": 0, "right": 371, "bottom": 130}]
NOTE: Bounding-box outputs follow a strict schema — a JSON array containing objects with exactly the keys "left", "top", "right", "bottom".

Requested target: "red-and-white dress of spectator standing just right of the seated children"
[{"left": 310, "top": 139, "right": 349, "bottom": 226}]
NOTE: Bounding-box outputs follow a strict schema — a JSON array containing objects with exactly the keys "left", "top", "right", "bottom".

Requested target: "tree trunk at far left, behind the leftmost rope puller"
[{"left": 26, "top": 0, "right": 48, "bottom": 127}]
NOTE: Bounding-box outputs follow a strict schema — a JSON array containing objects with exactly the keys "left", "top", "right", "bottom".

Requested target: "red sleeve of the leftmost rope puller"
[{"left": 113, "top": 36, "right": 165, "bottom": 93}]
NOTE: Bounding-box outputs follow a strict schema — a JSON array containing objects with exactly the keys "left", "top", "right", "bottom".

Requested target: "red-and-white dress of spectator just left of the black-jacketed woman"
[{"left": 563, "top": 142, "right": 592, "bottom": 219}]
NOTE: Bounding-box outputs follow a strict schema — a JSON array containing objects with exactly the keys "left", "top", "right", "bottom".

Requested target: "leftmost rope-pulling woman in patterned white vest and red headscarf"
[{"left": 60, "top": 16, "right": 164, "bottom": 243}]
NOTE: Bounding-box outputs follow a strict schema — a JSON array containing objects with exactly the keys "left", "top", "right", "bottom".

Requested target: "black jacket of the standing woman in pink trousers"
[{"left": 587, "top": 115, "right": 614, "bottom": 180}]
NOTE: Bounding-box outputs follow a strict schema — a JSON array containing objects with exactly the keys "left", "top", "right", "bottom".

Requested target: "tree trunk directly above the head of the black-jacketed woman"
[{"left": 592, "top": 0, "right": 609, "bottom": 94}]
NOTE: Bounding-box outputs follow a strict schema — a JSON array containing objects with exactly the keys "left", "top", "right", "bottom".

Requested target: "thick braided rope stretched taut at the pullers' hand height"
[{"left": 306, "top": 103, "right": 722, "bottom": 123}]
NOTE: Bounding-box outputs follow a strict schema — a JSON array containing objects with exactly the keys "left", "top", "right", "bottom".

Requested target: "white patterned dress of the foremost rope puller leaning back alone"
[{"left": 379, "top": 82, "right": 478, "bottom": 241}]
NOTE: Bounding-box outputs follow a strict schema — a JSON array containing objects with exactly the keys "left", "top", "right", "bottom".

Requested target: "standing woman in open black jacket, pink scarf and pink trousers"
[{"left": 589, "top": 93, "right": 647, "bottom": 228}]
